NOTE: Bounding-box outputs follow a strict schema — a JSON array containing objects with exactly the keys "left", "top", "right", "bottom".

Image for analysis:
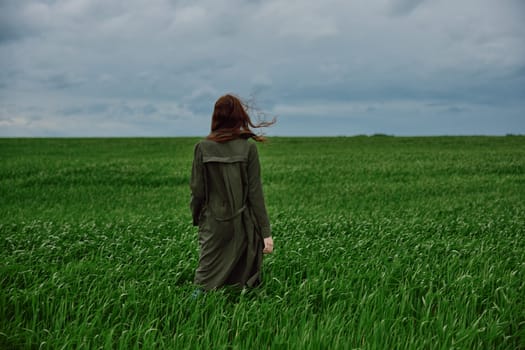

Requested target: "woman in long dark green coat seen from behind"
[{"left": 190, "top": 95, "right": 275, "bottom": 290}]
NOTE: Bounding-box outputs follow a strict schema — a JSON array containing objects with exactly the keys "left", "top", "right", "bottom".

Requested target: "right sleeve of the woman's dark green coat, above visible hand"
[{"left": 248, "top": 144, "right": 272, "bottom": 238}]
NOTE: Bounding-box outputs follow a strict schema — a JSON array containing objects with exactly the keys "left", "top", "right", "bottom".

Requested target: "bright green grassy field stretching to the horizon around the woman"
[{"left": 0, "top": 136, "right": 525, "bottom": 349}]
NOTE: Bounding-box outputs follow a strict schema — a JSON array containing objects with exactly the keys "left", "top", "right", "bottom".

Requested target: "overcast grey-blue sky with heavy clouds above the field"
[{"left": 0, "top": 0, "right": 525, "bottom": 136}]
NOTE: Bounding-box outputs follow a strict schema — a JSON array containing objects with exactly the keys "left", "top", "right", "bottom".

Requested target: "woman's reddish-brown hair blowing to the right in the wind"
[{"left": 207, "top": 94, "right": 275, "bottom": 142}]
